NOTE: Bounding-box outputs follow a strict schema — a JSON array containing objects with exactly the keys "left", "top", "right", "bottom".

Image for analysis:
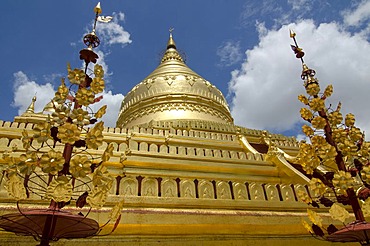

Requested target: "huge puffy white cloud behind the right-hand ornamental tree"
[{"left": 229, "top": 20, "right": 370, "bottom": 136}]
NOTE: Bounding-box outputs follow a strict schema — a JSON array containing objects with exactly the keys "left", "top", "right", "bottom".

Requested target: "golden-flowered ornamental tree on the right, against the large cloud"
[{"left": 290, "top": 31, "right": 370, "bottom": 245}]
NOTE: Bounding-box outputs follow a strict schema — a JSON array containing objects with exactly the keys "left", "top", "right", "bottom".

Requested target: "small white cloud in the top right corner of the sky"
[{"left": 343, "top": 0, "right": 370, "bottom": 26}]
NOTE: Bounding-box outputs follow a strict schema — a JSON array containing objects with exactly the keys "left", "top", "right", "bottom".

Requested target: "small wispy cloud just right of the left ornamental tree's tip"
[{"left": 96, "top": 12, "right": 132, "bottom": 45}]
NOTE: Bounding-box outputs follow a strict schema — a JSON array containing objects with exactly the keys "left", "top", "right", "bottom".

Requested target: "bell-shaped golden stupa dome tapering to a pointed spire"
[{"left": 117, "top": 34, "right": 233, "bottom": 127}]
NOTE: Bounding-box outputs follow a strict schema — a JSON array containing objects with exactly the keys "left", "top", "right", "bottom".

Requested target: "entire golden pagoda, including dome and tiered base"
[{"left": 0, "top": 34, "right": 346, "bottom": 246}]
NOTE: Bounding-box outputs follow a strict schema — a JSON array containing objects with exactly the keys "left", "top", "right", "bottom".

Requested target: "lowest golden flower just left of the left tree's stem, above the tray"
[{"left": 46, "top": 176, "right": 72, "bottom": 202}]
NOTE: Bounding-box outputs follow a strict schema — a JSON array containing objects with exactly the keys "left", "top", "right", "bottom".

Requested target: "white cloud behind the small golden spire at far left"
[{"left": 12, "top": 71, "right": 54, "bottom": 115}]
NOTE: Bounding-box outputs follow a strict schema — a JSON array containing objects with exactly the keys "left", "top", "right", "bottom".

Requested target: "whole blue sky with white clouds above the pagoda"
[{"left": 0, "top": 0, "right": 370, "bottom": 136}]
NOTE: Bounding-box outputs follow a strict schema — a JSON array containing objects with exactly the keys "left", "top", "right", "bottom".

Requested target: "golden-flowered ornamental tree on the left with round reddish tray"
[{"left": 0, "top": 3, "right": 123, "bottom": 245}]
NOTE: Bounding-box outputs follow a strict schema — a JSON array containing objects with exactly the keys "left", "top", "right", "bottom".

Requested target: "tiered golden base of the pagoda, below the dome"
[{"left": 0, "top": 115, "right": 336, "bottom": 245}]
